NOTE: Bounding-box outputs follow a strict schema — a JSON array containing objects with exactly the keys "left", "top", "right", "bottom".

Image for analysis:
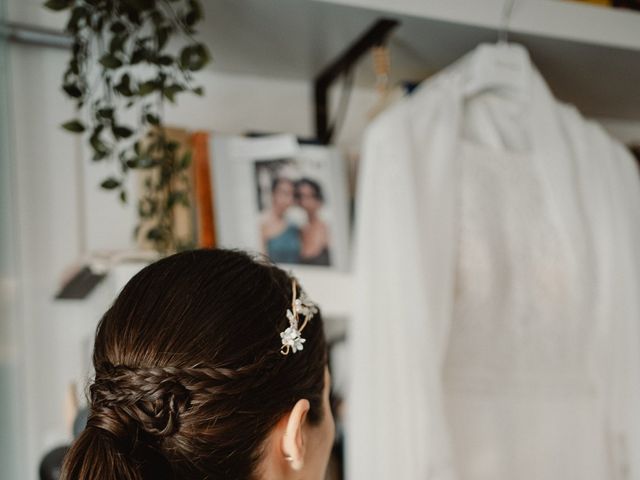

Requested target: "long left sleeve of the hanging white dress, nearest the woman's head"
[{"left": 346, "top": 87, "right": 456, "bottom": 480}]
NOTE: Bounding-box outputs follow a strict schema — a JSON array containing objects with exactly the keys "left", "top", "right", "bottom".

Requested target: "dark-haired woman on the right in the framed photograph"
[{"left": 296, "top": 178, "right": 331, "bottom": 266}]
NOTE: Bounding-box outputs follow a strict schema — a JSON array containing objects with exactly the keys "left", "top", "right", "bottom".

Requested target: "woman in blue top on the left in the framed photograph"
[{"left": 260, "top": 177, "right": 301, "bottom": 263}]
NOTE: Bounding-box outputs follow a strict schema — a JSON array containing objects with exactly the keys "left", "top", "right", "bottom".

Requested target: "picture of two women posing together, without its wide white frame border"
[{"left": 256, "top": 160, "right": 331, "bottom": 266}]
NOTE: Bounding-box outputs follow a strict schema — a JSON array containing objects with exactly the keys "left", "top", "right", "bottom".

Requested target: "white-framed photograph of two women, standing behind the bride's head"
[{"left": 210, "top": 133, "right": 349, "bottom": 270}]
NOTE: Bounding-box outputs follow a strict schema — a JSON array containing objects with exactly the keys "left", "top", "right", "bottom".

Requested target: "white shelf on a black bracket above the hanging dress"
[{"left": 202, "top": 0, "right": 640, "bottom": 120}]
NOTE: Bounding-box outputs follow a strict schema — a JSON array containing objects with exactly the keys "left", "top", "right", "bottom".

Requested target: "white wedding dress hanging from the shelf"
[{"left": 347, "top": 45, "right": 640, "bottom": 480}]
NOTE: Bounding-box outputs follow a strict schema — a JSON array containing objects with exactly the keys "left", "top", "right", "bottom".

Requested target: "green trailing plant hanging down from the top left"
[{"left": 44, "top": 0, "right": 210, "bottom": 252}]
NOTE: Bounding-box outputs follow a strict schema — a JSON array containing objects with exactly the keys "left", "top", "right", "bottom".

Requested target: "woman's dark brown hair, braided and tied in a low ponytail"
[{"left": 62, "top": 250, "right": 326, "bottom": 480}]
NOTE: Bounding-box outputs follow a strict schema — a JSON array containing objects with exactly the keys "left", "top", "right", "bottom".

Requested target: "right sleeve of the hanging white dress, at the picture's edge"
[{"left": 607, "top": 142, "right": 640, "bottom": 480}]
